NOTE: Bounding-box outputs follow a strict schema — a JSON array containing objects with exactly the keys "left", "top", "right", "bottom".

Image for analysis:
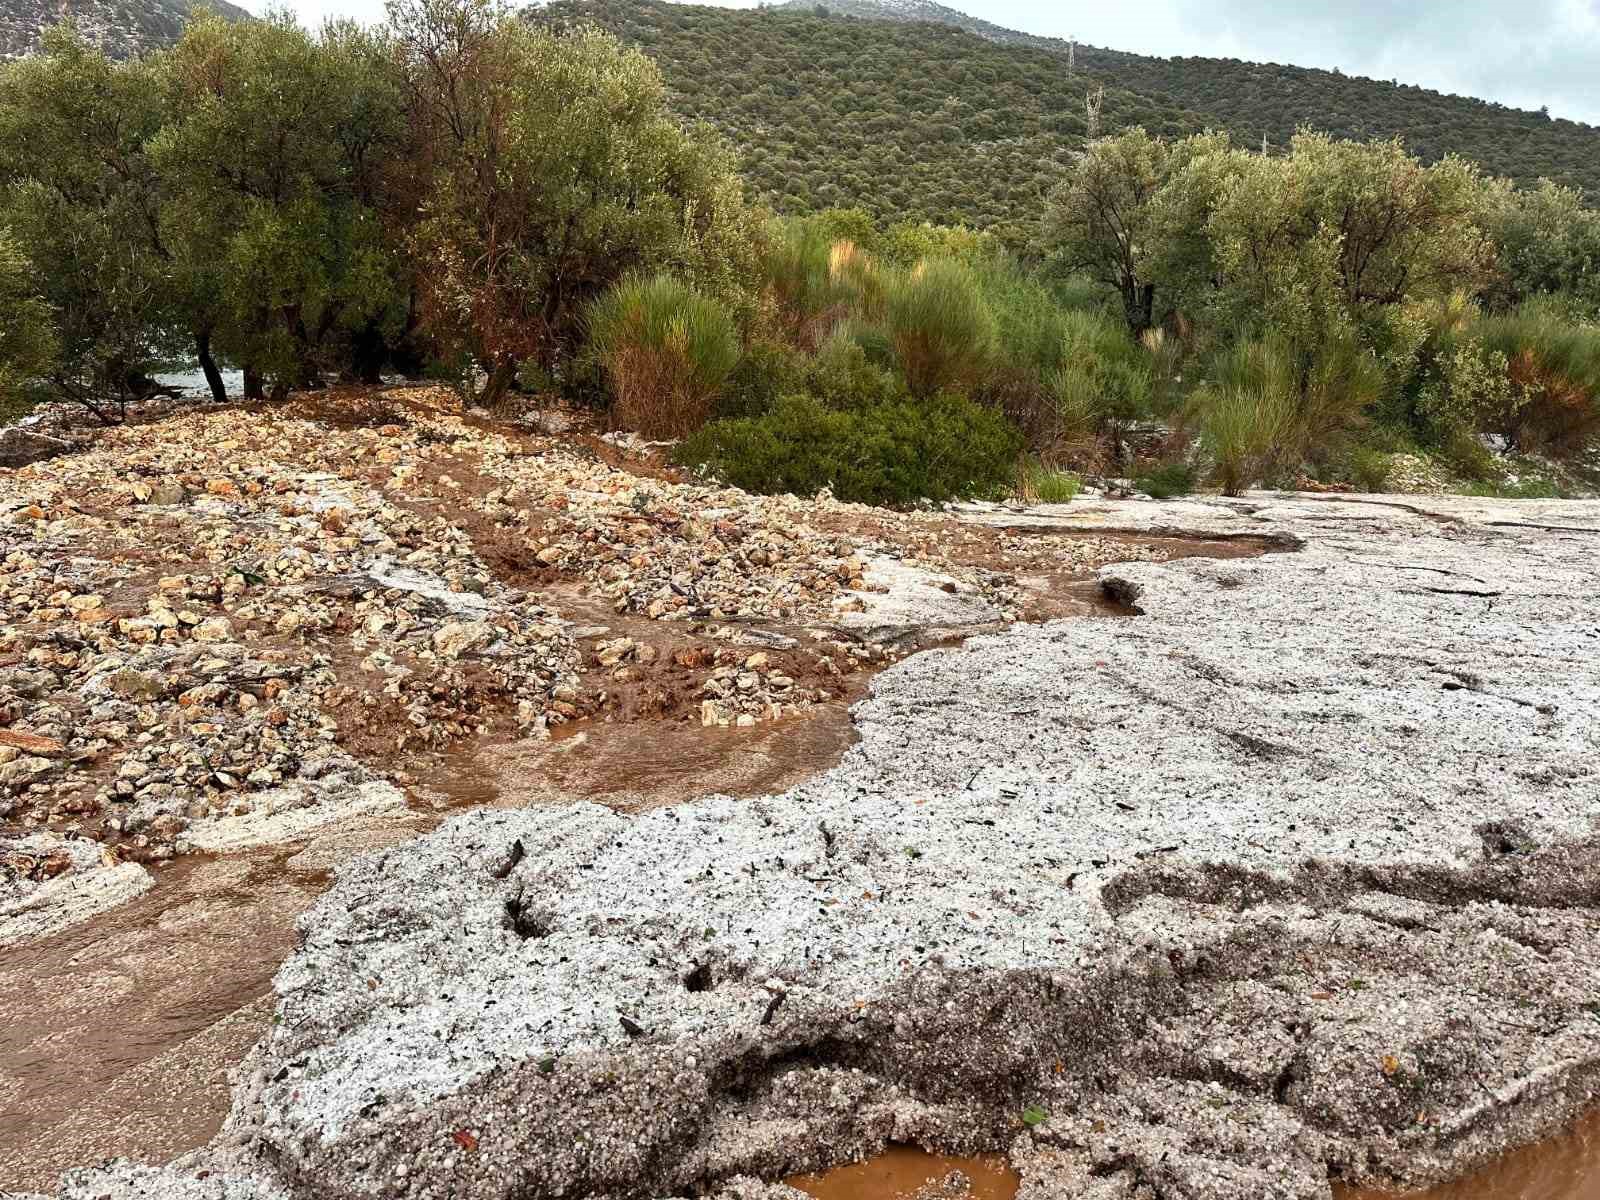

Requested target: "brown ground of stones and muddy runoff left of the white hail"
[{"left": 0, "top": 389, "right": 1262, "bottom": 1190}]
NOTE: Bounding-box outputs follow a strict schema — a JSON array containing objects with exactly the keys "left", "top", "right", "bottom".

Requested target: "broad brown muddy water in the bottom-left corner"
[{"left": 0, "top": 851, "right": 326, "bottom": 1190}]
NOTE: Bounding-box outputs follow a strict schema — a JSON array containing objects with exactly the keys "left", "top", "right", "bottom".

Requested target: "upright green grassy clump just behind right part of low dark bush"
[{"left": 883, "top": 259, "right": 995, "bottom": 398}]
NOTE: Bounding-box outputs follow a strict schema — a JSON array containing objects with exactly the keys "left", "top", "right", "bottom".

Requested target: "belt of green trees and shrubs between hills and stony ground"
[{"left": 0, "top": 0, "right": 1600, "bottom": 504}]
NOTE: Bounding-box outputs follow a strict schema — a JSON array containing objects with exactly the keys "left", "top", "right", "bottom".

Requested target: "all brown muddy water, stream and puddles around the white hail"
[{"left": 0, "top": 539, "right": 1600, "bottom": 1200}]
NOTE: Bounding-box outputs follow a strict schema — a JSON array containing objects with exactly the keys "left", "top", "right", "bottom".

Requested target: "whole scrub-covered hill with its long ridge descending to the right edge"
[{"left": 542, "top": 0, "right": 1600, "bottom": 241}]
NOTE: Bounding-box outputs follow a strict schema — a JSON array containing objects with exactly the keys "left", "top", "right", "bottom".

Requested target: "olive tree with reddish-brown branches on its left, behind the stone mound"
[{"left": 389, "top": 0, "right": 752, "bottom": 403}]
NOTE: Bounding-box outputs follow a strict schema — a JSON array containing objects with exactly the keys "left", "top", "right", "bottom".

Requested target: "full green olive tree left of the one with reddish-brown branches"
[{"left": 152, "top": 13, "right": 405, "bottom": 395}]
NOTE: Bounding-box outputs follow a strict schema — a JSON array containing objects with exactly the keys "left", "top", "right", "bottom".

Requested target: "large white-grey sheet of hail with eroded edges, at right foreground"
[{"left": 53, "top": 496, "right": 1600, "bottom": 1200}]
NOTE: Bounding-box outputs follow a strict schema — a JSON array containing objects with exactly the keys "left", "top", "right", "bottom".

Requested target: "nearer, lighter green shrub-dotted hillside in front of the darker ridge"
[{"left": 541, "top": 0, "right": 1208, "bottom": 241}]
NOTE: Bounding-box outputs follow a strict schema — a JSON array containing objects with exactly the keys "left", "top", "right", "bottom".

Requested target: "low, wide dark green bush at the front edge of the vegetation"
[{"left": 675, "top": 394, "right": 1021, "bottom": 507}]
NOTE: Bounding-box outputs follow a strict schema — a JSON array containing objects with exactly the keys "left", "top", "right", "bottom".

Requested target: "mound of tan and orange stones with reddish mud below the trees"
[{"left": 0, "top": 389, "right": 1177, "bottom": 889}]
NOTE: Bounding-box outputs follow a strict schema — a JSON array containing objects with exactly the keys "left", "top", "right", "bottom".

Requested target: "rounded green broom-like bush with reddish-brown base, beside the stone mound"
[{"left": 589, "top": 275, "right": 739, "bottom": 437}]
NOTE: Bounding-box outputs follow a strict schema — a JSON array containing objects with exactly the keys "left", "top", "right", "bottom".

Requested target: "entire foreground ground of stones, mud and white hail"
[{"left": 0, "top": 389, "right": 1600, "bottom": 1200}]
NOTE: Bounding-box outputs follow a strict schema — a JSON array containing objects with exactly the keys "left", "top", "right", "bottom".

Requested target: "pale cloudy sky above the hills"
[{"left": 262, "top": 0, "right": 1600, "bottom": 125}]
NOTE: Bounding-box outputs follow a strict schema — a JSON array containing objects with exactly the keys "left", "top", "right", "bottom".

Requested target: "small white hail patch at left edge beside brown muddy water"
[{"left": 0, "top": 832, "right": 154, "bottom": 947}]
